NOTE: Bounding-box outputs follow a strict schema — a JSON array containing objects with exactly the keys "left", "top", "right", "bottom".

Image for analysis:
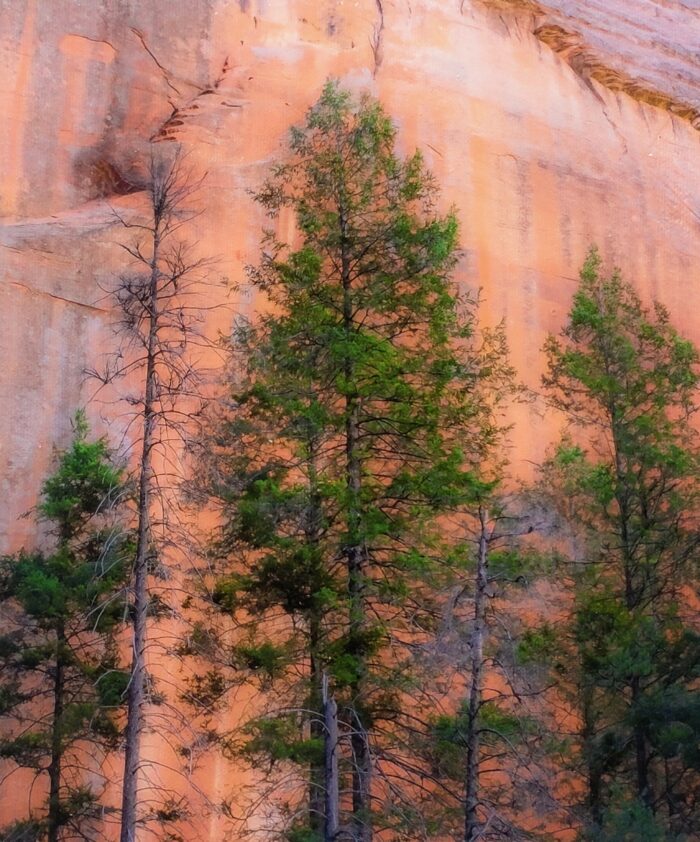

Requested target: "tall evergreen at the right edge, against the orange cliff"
[{"left": 545, "top": 251, "right": 700, "bottom": 839}]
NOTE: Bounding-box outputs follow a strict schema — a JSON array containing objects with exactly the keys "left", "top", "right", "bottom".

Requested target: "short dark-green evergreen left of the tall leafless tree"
[{"left": 0, "top": 414, "right": 128, "bottom": 842}]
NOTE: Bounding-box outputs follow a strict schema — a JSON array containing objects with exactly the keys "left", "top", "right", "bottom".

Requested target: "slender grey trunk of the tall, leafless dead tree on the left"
[{"left": 119, "top": 223, "right": 160, "bottom": 842}]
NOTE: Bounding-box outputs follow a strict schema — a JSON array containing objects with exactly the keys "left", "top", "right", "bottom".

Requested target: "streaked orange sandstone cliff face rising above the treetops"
[{"left": 0, "top": 0, "right": 700, "bottom": 839}]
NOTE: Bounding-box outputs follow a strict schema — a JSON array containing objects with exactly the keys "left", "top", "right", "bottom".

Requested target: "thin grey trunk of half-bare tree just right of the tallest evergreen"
[{"left": 464, "top": 506, "right": 489, "bottom": 842}]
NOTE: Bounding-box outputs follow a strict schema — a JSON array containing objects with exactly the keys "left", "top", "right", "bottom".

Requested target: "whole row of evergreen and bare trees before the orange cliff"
[{"left": 0, "top": 83, "right": 700, "bottom": 842}]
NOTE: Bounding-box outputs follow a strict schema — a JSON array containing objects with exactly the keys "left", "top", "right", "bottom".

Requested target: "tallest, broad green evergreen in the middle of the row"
[{"left": 194, "top": 83, "right": 506, "bottom": 842}]
